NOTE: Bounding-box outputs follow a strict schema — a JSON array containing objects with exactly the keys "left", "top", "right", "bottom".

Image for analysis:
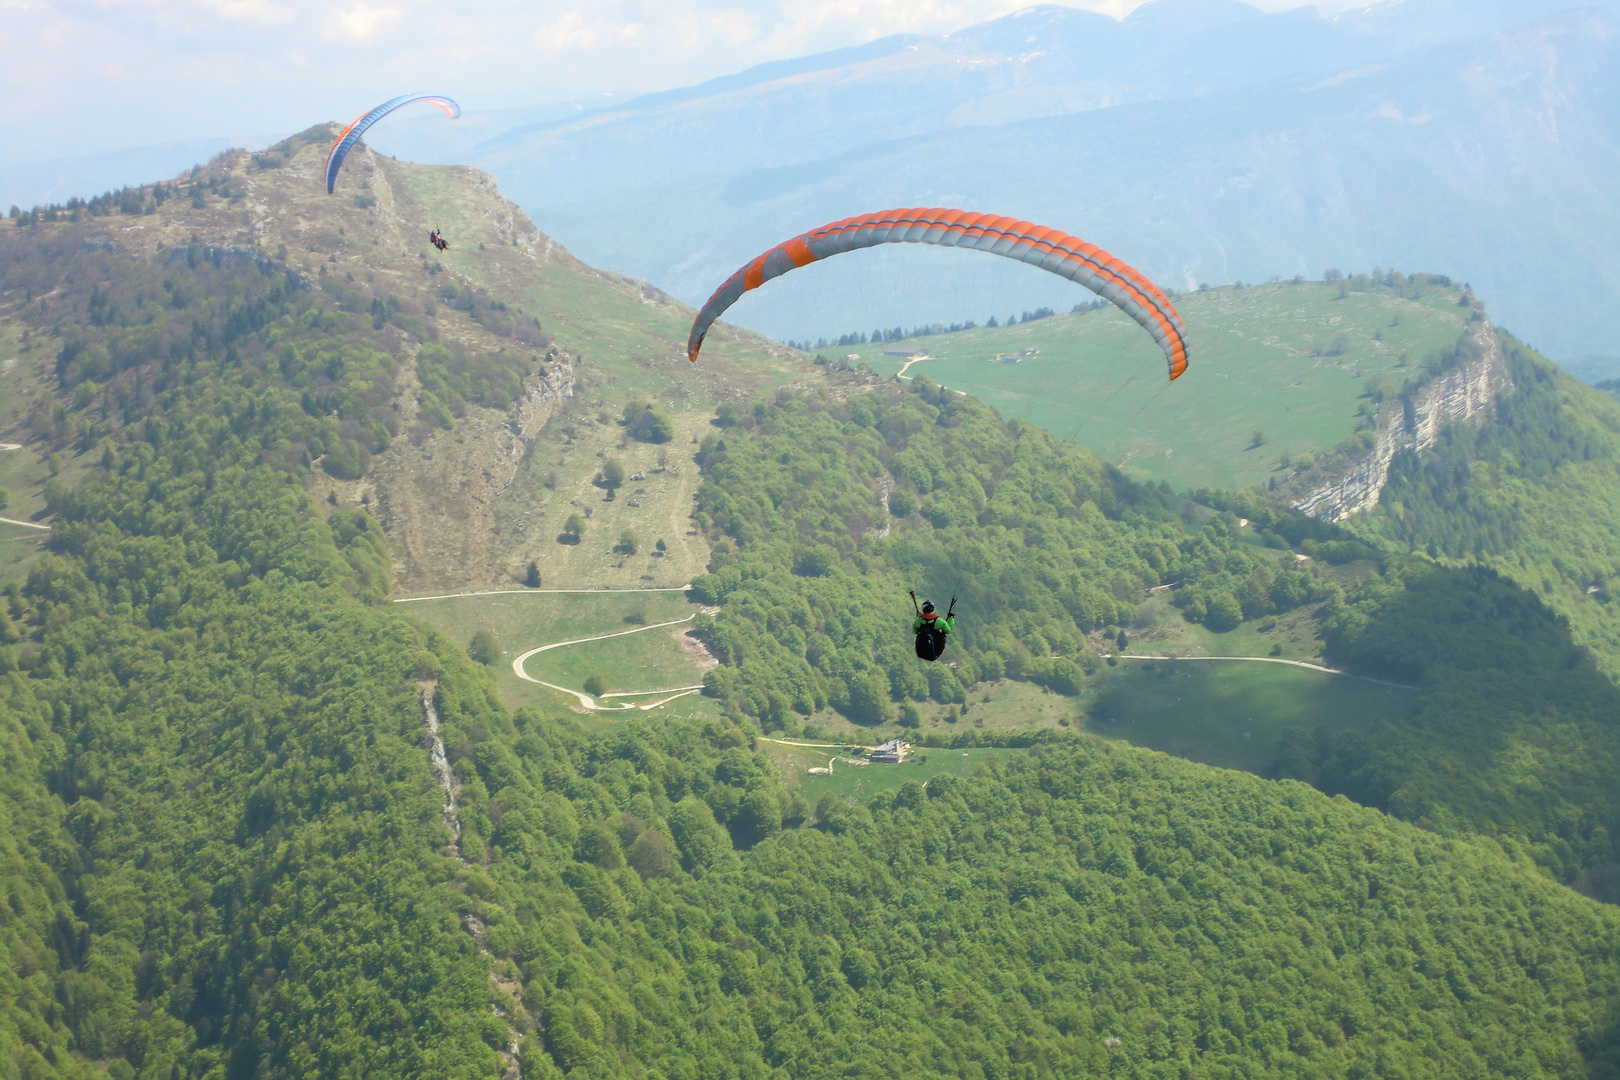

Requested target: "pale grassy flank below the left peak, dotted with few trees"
[{"left": 386, "top": 165, "right": 826, "bottom": 588}]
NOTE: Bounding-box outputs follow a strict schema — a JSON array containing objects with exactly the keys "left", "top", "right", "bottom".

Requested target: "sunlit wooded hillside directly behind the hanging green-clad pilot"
[{"left": 693, "top": 379, "right": 1337, "bottom": 724}]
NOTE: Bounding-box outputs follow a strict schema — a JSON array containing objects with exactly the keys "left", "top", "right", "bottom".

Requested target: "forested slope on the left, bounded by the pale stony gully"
[{"left": 0, "top": 232, "right": 505, "bottom": 1077}]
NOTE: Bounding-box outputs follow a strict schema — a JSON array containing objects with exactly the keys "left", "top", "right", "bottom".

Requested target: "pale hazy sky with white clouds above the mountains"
[{"left": 0, "top": 0, "right": 1354, "bottom": 167}]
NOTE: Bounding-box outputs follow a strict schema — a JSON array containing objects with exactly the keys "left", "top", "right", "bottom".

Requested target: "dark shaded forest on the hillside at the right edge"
[{"left": 1268, "top": 559, "right": 1620, "bottom": 902}]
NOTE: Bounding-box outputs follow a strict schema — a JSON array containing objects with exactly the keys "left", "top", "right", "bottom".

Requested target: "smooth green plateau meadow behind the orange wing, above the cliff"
[{"left": 861, "top": 282, "right": 1466, "bottom": 489}]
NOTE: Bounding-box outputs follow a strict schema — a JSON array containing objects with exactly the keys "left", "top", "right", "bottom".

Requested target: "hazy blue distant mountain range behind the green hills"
[{"left": 411, "top": 0, "right": 1620, "bottom": 366}]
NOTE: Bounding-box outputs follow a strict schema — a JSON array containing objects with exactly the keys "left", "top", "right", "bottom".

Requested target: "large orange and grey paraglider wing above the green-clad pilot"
[{"left": 687, "top": 207, "right": 1187, "bottom": 379}]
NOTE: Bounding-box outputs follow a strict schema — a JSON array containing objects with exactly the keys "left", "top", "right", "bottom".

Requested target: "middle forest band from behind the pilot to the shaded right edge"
[{"left": 693, "top": 379, "right": 1620, "bottom": 895}]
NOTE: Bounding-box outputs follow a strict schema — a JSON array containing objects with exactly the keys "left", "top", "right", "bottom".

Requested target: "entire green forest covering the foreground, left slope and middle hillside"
[{"left": 9, "top": 173, "right": 1620, "bottom": 1080}]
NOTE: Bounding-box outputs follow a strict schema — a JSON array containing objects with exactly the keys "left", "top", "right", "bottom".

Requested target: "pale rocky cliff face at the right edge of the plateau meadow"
[{"left": 1290, "top": 319, "right": 1513, "bottom": 521}]
